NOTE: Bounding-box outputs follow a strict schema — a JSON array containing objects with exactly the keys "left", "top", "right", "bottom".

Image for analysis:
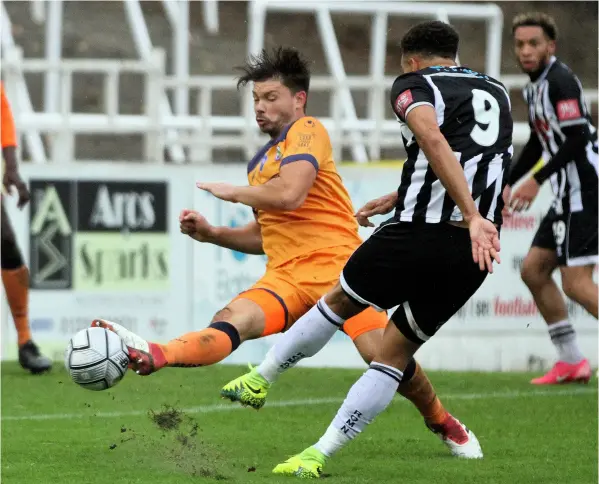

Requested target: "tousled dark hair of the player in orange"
[{"left": 237, "top": 47, "right": 310, "bottom": 94}]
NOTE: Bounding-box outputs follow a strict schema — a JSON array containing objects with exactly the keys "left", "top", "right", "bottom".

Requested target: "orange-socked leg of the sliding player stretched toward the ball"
[{"left": 92, "top": 299, "right": 271, "bottom": 375}]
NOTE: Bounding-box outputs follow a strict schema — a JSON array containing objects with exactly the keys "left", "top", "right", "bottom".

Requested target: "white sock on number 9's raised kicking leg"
[{"left": 257, "top": 297, "right": 345, "bottom": 383}]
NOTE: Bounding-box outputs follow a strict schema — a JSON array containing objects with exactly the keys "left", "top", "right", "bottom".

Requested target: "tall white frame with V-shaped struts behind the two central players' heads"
[{"left": 244, "top": 0, "right": 503, "bottom": 162}]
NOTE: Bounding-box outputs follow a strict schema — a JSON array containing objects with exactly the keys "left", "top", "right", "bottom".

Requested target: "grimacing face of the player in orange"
[{"left": 252, "top": 80, "right": 306, "bottom": 137}]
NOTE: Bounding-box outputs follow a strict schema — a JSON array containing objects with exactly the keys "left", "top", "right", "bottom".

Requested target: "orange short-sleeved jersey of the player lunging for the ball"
[{"left": 248, "top": 116, "right": 362, "bottom": 270}]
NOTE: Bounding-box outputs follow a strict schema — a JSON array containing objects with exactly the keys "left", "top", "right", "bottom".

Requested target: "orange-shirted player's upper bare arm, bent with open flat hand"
[{"left": 197, "top": 160, "right": 316, "bottom": 211}]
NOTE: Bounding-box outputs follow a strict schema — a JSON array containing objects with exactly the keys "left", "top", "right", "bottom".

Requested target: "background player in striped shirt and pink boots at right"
[{"left": 509, "top": 13, "right": 598, "bottom": 385}]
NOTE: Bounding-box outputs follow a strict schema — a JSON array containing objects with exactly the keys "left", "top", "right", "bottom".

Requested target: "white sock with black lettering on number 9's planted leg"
[{"left": 314, "top": 362, "right": 403, "bottom": 457}]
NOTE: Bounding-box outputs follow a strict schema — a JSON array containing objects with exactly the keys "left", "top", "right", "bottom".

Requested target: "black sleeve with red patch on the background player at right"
[{"left": 549, "top": 71, "right": 587, "bottom": 128}]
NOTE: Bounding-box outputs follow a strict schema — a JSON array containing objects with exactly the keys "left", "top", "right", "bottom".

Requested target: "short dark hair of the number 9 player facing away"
[{"left": 400, "top": 20, "right": 460, "bottom": 60}]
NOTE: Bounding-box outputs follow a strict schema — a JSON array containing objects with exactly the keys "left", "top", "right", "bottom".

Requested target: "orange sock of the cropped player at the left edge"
[{"left": 2, "top": 266, "right": 31, "bottom": 346}]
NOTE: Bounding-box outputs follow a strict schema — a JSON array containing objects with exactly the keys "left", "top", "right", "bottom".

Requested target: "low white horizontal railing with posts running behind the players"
[{"left": 3, "top": 48, "right": 597, "bottom": 163}]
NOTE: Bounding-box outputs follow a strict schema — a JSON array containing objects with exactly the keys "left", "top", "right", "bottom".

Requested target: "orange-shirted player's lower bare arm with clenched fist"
[{"left": 179, "top": 210, "right": 264, "bottom": 255}]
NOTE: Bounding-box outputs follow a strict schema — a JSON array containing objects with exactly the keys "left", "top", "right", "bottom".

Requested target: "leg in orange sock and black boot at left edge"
[{"left": 0, "top": 206, "right": 52, "bottom": 373}]
